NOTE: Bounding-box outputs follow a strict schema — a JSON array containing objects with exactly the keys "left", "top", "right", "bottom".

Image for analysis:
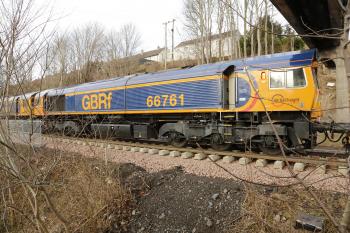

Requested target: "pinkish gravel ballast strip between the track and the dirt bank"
[{"left": 44, "top": 138, "right": 350, "bottom": 192}]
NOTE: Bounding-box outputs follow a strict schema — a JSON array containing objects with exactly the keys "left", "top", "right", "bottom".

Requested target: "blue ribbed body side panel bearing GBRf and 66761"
[{"left": 61, "top": 75, "right": 223, "bottom": 114}]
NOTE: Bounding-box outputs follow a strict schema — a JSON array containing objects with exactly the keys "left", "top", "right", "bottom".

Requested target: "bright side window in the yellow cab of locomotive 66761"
[{"left": 270, "top": 68, "right": 306, "bottom": 88}]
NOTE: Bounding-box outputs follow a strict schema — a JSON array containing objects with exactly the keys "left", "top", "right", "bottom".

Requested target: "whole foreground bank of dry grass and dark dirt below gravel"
[{"left": 0, "top": 149, "right": 345, "bottom": 233}]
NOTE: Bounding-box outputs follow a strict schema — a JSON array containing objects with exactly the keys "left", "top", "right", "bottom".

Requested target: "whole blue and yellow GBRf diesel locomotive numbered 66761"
[{"left": 4, "top": 49, "right": 349, "bottom": 154}]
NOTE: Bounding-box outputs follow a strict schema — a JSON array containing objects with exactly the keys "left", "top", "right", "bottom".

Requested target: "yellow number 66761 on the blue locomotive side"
[{"left": 146, "top": 94, "right": 185, "bottom": 108}]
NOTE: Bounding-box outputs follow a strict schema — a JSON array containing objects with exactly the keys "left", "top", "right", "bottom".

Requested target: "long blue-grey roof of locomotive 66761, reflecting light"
[{"left": 21, "top": 49, "right": 316, "bottom": 96}]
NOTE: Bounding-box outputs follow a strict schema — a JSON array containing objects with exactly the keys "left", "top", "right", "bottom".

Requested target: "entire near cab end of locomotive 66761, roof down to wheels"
[{"left": 219, "top": 50, "right": 321, "bottom": 154}]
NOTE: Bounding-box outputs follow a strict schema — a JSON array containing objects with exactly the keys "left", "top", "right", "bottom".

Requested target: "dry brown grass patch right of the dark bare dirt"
[{"left": 228, "top": 186, "right": 345, "bottom": 233}]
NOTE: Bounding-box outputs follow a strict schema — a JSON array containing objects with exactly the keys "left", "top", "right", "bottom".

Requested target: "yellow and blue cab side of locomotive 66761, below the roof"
[{"left": 228, "top": 66, "right": 319, "bottom": 114}]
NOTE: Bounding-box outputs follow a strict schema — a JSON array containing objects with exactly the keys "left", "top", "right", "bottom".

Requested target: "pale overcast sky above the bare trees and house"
[{"left": 41, "top": 0, "right": 286, "bottom": 51}]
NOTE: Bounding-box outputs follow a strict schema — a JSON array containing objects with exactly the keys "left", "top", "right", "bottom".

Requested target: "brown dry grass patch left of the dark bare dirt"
[{"left": 0, "top": 147, "right": 131, "bottom": 233}]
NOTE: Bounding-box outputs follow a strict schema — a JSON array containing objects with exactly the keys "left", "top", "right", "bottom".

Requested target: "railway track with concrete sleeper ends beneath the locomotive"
[{"left": 43, "top": 135, "right": 349, "bottom": 170}]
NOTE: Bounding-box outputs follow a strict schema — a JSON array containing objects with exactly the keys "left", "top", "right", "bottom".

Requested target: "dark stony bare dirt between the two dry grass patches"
[{"left": 117, "top": 164, "right": 244, "bottom": 232}]
